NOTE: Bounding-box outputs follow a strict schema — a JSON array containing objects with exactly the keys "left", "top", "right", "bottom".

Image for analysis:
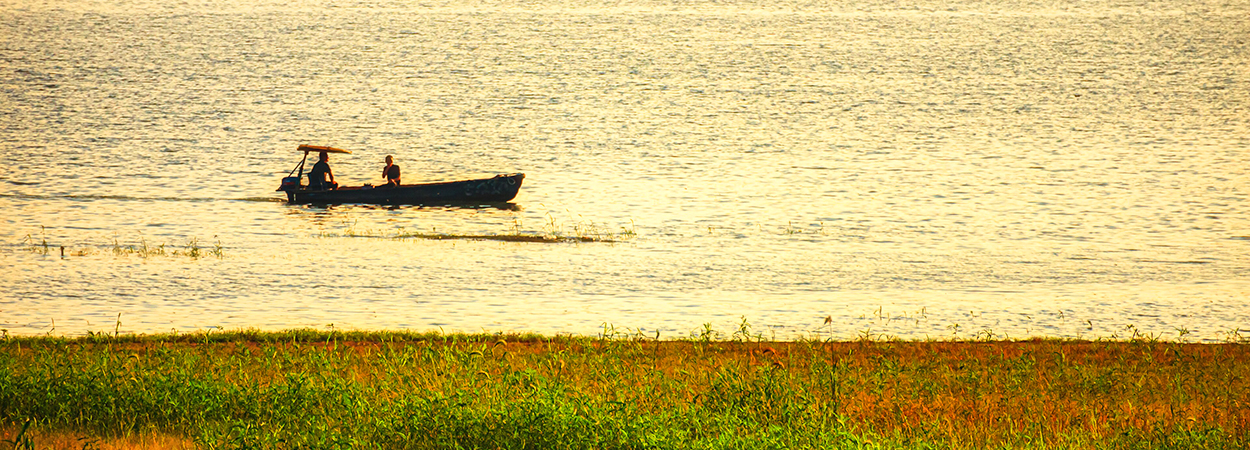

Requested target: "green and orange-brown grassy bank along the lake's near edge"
[{"left": 0, "top": 330, "right": 1250, "bottom": 449}]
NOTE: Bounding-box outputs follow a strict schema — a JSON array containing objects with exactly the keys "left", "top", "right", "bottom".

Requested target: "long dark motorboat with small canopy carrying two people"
[{"left": 278, "top": 144, "right": 525, "bottom": 205}]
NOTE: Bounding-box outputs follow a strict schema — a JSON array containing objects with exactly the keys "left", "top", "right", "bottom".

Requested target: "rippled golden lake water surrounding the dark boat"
[{"left": 0, "top": 0, "right": 1250, "bottom": 341}]
